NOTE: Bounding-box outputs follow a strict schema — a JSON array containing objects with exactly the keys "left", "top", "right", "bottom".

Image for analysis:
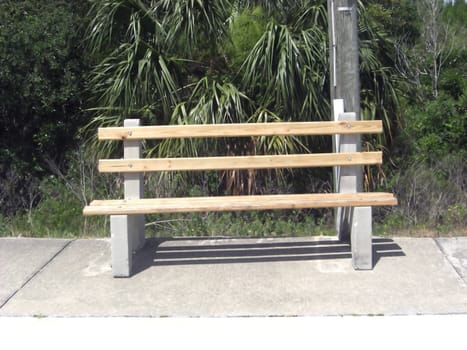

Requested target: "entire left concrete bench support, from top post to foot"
[{"left": 110, "top": 119, "right": 145, "bottom": 277}]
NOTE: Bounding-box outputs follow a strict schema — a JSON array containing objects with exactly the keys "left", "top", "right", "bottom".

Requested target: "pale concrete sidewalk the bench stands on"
[{"left": 0, "top": 237, "right": 467, "bottom": 317}]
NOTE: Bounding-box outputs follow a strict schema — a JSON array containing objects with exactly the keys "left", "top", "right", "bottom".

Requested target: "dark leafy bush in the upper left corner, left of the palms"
[{"left": 0, "top": 0, "right": 91, "bottom": 216}]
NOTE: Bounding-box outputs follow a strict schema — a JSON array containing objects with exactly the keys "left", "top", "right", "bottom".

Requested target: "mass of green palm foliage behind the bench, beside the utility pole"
[{"left": 87, "top": 0, "right": 400, "bottom": 193}]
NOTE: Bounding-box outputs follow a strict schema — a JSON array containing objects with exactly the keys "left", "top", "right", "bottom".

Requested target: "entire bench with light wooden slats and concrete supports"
[{"left": 83, "top": 101, "right": 397, "bottom": 277}]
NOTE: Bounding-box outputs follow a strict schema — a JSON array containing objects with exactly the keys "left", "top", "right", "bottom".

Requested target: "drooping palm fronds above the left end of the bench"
[{"left": 87, "top": 0, "right": 230, "bottom": 123}]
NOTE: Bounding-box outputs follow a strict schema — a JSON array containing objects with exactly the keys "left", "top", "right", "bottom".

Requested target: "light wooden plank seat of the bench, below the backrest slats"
[{"left": 83, "top": 192, "right": 397, "bottom": 215}]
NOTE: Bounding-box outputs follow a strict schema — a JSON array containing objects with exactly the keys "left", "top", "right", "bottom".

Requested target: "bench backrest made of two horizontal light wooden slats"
[{"left": 98, "top": 120, "right": 383, "bottom": 173}]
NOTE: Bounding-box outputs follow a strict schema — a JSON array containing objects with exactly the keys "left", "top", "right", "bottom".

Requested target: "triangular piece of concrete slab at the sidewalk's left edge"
[{"left": 0, "top": 238, "right": 70, "bottom": 307}]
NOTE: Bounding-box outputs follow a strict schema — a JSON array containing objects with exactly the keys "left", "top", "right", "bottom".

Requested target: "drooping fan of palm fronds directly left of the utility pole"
[{"left": 242, "top": 22, "right": 328, "bottom": 120}]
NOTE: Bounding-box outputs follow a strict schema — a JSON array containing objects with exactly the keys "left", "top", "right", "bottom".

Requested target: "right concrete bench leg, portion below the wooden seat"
[{"left": 350, "top": 207, "right": 373, "bottom": 270}]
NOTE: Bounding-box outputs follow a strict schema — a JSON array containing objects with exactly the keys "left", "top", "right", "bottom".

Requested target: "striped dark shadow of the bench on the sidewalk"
[{"left": 132, "top": 237, "right": 405, "bottom": 275}]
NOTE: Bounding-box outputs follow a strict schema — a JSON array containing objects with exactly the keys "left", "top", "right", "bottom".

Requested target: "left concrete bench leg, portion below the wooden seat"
[{"left": 110, "top": 215, "right": 145, "bottom": 277}]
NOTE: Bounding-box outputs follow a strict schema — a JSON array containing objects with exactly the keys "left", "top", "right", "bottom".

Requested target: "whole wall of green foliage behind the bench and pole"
[{"left": 0, "top": 0, "right": 467, "bottom": 236}]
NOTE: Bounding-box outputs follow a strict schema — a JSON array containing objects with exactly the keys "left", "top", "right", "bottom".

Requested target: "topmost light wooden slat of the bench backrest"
[{"left": 98, "top": 120, "right": 383, "bottom": 140}]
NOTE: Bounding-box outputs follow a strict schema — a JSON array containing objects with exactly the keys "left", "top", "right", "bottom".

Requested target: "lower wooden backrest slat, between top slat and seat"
[{"left": 99, "top": 152, "right": 383, "bottom": 173}]
